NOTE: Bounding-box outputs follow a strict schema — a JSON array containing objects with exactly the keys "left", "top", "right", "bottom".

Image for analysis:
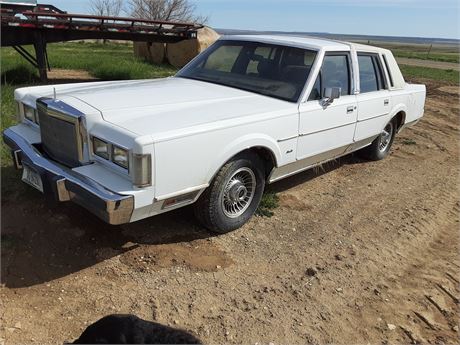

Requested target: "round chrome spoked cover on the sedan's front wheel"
[{"left": 222, "top": 168, "right": 256, "bottom": 218}]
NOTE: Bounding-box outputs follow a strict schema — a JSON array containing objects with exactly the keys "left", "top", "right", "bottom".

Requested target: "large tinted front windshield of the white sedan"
[{"left": 176, "top": 40, "right": 316, "bottom": 102}]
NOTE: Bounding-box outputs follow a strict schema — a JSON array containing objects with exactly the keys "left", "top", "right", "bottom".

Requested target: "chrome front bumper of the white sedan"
[{"left": 3, "top": 129, "right": 134, "bottom": 225}]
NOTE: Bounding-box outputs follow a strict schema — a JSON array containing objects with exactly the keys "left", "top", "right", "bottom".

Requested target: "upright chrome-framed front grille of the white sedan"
[{"left": 37, "top": 98, "right": 85, "bottom": 167}]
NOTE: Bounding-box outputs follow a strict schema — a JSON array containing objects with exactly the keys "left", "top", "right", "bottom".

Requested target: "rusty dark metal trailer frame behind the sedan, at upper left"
[{"left": 0, "top": 4, "right": 202, "bottom": 80}]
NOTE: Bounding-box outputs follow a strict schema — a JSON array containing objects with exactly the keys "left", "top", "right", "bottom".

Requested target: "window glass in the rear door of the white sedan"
[{"left": 358, "top": 54, "right": 387, "bottom": 93}]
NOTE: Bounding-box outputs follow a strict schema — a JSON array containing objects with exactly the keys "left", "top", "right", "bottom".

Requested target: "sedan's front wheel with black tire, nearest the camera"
[{"left": 194, "top": 153, "right": 265, "bottom": 234}]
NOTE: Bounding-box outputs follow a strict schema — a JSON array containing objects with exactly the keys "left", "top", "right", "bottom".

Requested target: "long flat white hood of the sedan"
[{"left": 15, "top": 77, "right": 297, "bottom": 137}]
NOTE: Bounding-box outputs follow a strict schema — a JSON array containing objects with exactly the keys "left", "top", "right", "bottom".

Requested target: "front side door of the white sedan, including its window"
[{"left": 297, "top": 52, "right": 358, "bottom": 161}]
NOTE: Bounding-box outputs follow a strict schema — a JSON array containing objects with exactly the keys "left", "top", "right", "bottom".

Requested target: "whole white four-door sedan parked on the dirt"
[{"left": 3, "top": 36, "right": 426, "bottom": 233}]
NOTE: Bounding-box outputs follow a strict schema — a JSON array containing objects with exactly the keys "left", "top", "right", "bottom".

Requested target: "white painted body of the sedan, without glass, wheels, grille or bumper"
[{"left": 7, "top": 36, "right": 425, "bottom": 221}]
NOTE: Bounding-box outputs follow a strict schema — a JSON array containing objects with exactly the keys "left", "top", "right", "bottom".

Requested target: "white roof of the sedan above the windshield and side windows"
[{"left": 221, "top": 35, "right": 385, "bottom": 53}]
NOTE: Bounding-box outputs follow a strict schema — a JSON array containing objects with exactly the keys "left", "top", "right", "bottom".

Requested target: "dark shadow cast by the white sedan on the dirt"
[{"left": 1, "top": 156, "right": 364, "bottom": 288}]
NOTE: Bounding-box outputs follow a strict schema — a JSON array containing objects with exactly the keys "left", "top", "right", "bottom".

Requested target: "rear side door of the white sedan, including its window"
[{"left": 354, "top": 52, "right": 391, "bottom": 143}]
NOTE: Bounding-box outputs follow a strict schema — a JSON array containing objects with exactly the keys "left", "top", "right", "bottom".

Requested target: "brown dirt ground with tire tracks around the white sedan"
[{"left": 0, "top": 80, "right": 460, "bottom": 344}]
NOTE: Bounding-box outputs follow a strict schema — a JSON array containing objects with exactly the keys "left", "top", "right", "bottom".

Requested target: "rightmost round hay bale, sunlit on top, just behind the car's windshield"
[{"left": 166, "top": 27, "right": 219, "bottom": 68}]
